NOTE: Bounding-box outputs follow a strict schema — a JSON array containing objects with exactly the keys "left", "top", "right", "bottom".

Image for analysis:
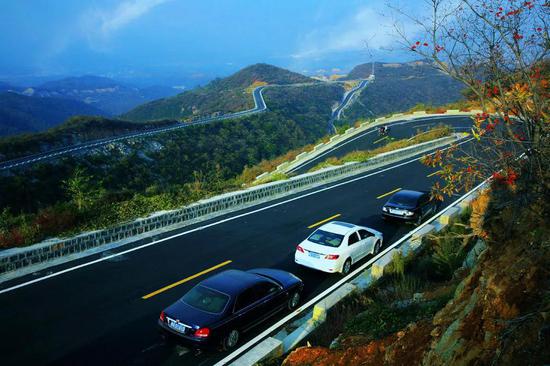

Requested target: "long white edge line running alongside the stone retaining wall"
[{"left": 0, "top": 138, "right": 473, "bottom": 295}]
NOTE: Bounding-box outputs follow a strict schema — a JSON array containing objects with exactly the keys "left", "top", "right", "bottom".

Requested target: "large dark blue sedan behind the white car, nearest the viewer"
[{"left": 158, "top": 268, "right": 303, "bottom": 350}]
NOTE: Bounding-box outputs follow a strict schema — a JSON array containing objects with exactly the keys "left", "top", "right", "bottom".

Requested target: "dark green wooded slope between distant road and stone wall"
[{"left": 0, "top": 112, "right": 326, "bottom": 248}]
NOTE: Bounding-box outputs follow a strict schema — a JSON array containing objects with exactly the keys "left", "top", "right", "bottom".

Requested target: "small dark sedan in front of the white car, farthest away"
[{"left": 382, "top": 189, "right": 438, "bottom": 225}]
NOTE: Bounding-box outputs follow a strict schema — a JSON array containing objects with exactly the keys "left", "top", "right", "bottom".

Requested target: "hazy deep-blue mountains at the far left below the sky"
[{"left": 0, "top": 75, "right": 181, "bottom": 136}]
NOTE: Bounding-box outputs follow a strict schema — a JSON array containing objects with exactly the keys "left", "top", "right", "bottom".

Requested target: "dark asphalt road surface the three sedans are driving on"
[{"left": 0, "top": 118, "right": 478, "bottom": 366}]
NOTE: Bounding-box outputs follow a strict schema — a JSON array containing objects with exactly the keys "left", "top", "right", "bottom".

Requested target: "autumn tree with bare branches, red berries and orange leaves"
[{"left": 390, "top": 0, "right": 550, "bottom": 199}]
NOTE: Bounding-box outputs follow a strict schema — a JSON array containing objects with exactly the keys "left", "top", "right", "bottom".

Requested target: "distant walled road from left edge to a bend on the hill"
[{"left": 0, "top": 85, "right": 267, "bottom": 171}]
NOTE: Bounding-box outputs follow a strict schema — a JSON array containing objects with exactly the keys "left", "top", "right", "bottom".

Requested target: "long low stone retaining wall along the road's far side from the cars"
[{"left": 0, "top": 135, "right": 464, "bottom": 275}]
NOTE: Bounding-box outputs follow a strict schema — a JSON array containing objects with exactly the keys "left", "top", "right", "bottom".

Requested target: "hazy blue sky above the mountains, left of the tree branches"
[{"left": 0, "top": 0, "right": 420, "bottom": 83}]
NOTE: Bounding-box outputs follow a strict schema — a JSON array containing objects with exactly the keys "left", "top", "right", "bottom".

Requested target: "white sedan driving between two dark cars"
[{"left": 294, "top": 221, "right": 383, "bottom": 275}]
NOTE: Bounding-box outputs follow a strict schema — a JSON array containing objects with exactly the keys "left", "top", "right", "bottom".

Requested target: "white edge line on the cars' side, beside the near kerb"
[{"left": 218, "top": 164, "right": 490, "bottom": 366}]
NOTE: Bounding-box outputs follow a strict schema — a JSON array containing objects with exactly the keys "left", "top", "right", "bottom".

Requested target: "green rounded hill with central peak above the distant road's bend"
[{"left": 121, "top": 64, "right": 318, "bottom": 121}]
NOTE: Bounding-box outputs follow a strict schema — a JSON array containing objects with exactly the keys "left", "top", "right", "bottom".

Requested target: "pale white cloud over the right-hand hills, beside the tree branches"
[{"left": 291, "top": 6, "right": 410, "bottom": 59}]
